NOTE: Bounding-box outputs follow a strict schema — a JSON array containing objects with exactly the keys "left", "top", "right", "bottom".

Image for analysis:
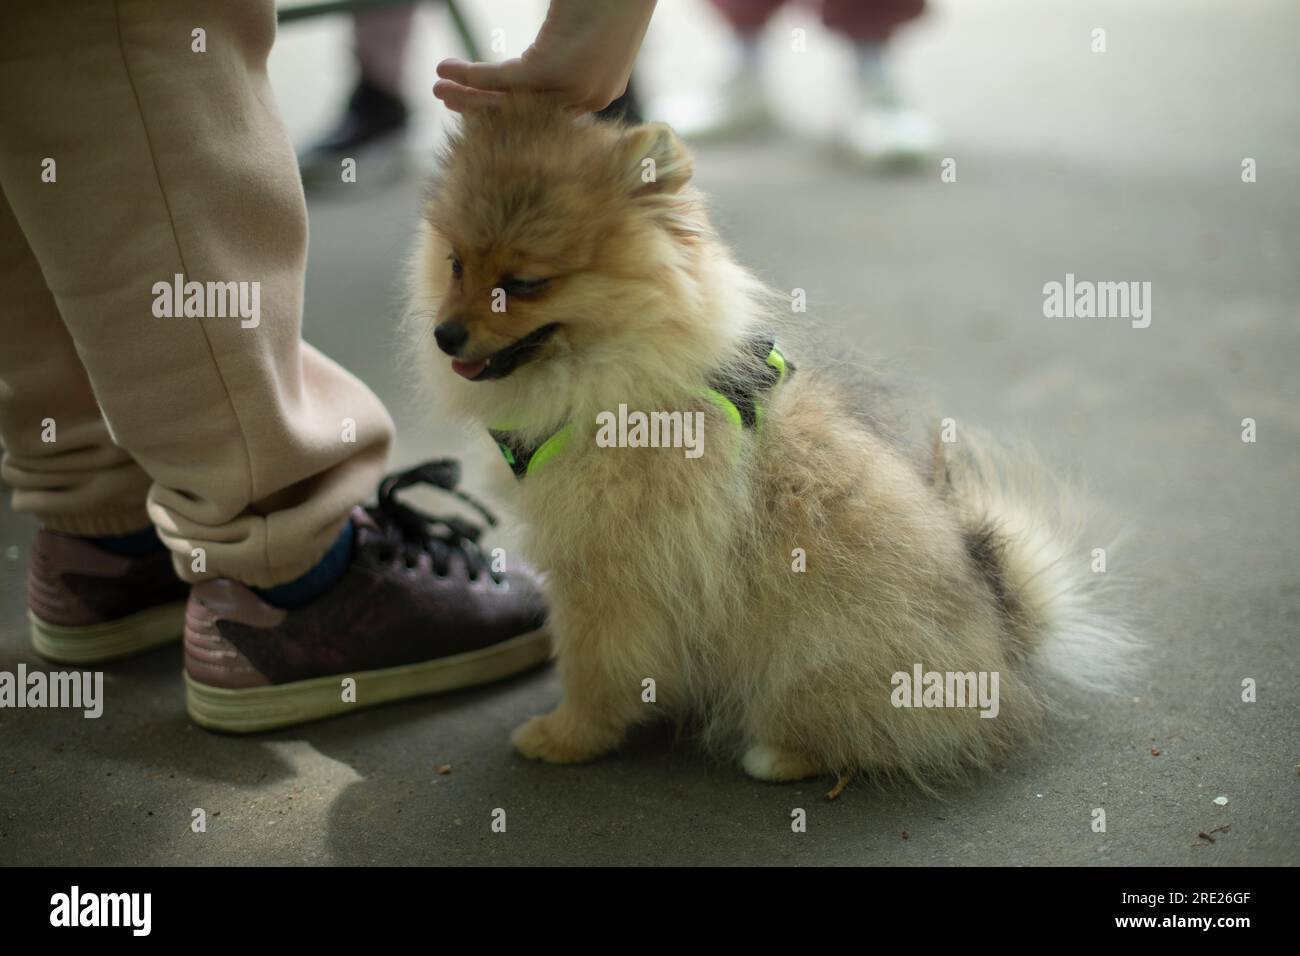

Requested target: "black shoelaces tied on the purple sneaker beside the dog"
[{"left": 367, "top": 458, "right": 502, "bottom": 584}]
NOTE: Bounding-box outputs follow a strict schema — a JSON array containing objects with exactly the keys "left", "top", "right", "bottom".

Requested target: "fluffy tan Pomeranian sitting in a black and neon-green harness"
[{"left": 411, "top": 96, "right": 1126, "bottom": 784}]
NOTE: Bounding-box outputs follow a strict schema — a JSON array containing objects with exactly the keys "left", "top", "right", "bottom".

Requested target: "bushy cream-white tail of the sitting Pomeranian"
[{"left": 935, "top": 429, "right": 1136, "bottom": 691}]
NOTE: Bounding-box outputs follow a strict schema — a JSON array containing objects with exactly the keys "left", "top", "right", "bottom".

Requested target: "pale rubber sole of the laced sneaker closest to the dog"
[{"left": 185, "top": 630, "right": 551, "bottom": 734}]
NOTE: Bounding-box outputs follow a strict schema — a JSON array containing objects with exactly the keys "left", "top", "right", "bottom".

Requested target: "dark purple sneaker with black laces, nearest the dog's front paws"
[{"left": 185, "top": 460, "right": 550, "bottom": 734}]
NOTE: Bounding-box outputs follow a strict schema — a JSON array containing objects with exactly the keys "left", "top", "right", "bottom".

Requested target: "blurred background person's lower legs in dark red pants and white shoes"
[{"left": 654, "top": 0, "right": 940, "bottom": 165}]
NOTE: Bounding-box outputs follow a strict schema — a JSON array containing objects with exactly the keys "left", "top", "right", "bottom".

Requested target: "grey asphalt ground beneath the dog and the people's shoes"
[{"left": 0, "top": 0, "right": 1300, "bottom": 865}]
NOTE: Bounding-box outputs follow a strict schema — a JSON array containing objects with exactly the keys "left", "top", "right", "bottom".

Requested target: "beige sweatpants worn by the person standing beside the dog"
[{"left": 0, "top": 0, "right": 393, "bottom": 587}]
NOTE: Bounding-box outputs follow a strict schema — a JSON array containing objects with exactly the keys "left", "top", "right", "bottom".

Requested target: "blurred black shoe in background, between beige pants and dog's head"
[{"left": 299, "top": 75, "right": 408, "bottom": 186}]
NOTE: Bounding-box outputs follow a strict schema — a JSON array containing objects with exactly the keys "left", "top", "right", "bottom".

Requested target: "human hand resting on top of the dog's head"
[{"left": 433, "top": 0, "right": 655, "bottom": 113}]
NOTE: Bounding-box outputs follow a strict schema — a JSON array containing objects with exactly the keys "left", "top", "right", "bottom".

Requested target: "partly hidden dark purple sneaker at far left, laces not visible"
[{"left": 27, "top": 529, "right": 190, "bottom": 665}]
